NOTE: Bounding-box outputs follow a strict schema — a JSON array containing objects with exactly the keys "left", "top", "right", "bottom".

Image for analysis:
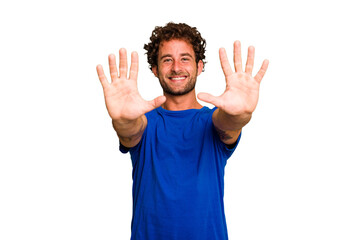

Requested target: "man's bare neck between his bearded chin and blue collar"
[{"left": 162, "top": 89, "right": 203, "bottom": 111}]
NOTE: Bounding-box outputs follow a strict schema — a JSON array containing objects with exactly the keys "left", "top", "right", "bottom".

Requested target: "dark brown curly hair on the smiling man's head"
[{"left": 144, "top": 22, "right": 206, "bottom": 71}]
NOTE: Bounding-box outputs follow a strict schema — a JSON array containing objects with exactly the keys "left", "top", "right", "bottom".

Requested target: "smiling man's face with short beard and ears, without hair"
[{"left": 152, "top": 39, "right": 203, "bottom": 96}]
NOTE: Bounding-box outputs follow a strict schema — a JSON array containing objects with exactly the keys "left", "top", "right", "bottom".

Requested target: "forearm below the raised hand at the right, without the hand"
[{"left": 212, "top": 108, "right": 252, "bottom": 145}]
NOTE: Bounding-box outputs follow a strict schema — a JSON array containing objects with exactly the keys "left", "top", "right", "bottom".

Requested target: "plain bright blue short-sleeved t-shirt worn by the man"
[{"left": 120, "top": 107, "right": 240, "bottom": 240}]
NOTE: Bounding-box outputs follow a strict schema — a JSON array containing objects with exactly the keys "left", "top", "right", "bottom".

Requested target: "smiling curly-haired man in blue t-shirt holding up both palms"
[{"left": 97, "top": 23, "right": 269, "bottom": 240}]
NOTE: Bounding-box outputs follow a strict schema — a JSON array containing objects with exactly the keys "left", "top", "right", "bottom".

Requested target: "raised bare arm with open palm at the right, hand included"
[{"left": 198, "top": 41, "right": 269, "bottom": 145}]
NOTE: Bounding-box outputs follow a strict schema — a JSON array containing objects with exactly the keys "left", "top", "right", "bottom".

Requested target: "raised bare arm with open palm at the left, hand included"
[{"left": 96, "top": 49, "right": 166, "bottom": 148}]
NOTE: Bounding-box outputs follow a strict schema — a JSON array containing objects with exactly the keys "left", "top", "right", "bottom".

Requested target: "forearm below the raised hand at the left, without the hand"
[{"left": 112, "top": 115, "right": 147, "bottom": 148}]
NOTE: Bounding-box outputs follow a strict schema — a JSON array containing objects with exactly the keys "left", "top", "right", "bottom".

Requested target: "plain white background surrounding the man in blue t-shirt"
[{"left": 0, "top": 0, "right": 360, "bottom": 240}]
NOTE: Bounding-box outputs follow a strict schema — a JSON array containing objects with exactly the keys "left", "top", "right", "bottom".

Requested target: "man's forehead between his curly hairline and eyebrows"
[{"left": 159, "top": 39, "right": 195, "bottom": 57}]
